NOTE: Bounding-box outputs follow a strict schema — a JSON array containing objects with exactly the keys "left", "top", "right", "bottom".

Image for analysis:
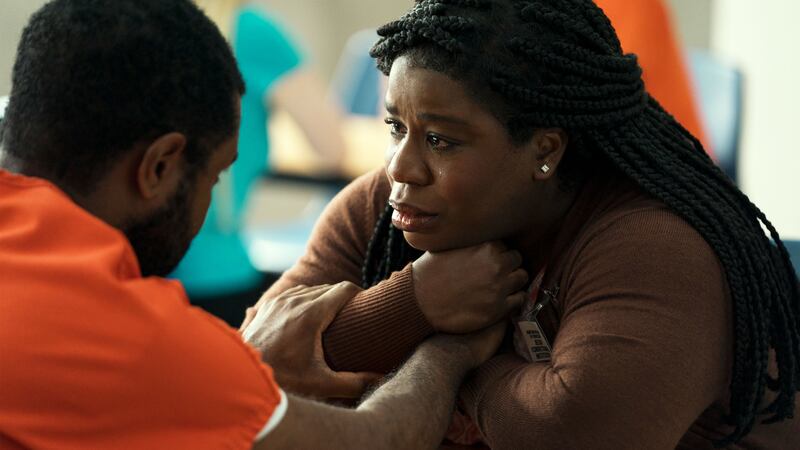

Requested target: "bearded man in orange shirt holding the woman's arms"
[{"left": 0, "top": 0, "right": 513, "bottom": 449}]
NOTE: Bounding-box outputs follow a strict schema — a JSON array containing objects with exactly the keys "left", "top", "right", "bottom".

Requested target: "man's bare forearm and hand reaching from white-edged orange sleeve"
[{"left": 255, "top": 332, "right": 504, "bottom": 450}]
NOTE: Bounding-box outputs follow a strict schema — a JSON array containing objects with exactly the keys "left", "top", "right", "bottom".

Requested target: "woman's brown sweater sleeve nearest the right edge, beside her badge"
[{"left": 461, "top": 210, "right": 731, "bottom": 450}]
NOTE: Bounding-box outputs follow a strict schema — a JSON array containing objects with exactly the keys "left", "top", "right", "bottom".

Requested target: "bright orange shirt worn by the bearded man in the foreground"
[{"left": 0, "top": 170, "right": 285, "bottom": 449}]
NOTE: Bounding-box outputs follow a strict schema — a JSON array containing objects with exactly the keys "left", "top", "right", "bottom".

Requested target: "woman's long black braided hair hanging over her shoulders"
[{"left": 363, "top": 0, "right": 800, "bottom": 446}]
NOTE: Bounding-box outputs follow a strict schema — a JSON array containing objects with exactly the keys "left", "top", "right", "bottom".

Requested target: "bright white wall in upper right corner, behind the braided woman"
[{"left": 711, "top": 0, "right": 800, "bottom": 239}]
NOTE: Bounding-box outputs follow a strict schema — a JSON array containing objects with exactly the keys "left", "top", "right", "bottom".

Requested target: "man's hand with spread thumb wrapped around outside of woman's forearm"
[{"left": 242, "top": 282, "right": 380, "bottom": 398}]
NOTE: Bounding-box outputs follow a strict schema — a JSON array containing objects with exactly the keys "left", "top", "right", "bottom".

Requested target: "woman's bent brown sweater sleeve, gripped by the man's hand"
[{"left": 265, "top": 170, "right": 433, "bottom": 373}]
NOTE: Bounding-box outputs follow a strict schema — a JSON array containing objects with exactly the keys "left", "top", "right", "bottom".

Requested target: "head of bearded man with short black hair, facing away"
[{"left": 3, "top": 0, "right": 244, "bottom": 275}]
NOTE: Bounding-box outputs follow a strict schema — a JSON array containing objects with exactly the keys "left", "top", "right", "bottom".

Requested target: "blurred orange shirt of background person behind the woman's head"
[{"left": 595, "top": 0, "right": 714, "bottom": 157}]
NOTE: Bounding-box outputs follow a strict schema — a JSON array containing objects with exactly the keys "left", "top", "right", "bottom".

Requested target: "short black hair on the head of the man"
[{"left": 3, "top": 0, "right": 244, "bottom": 193}]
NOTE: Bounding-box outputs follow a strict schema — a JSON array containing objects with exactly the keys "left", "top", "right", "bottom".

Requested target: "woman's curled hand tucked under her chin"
[{"left": 412, "top": 242, "right": 528, "bottom": 334}]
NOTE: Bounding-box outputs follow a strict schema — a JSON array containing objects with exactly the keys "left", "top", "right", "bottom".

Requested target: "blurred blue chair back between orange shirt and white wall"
[{"left": 688, "top": 50, "right": 743, "bottom": 182}]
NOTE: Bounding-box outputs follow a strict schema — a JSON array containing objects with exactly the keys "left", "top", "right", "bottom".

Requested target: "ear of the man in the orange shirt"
[{"left": 136, "top": 132, "right": 186, "bottom": 200}]
